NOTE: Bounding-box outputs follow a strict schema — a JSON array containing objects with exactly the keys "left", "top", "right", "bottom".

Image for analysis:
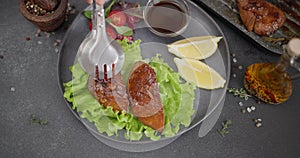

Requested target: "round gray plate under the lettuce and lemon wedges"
[{"left": 58, "top": 1, "right": 230, "bottom": 152}]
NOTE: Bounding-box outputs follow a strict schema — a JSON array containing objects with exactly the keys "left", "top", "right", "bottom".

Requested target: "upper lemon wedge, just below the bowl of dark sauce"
[{"left": 167, "top": 36, "right": 222, "bottom": 60}]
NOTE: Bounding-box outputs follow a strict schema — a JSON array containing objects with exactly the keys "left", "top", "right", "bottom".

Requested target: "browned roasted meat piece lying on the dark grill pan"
[{"left": 237, "top": 0, "right": 286, "bottom": 36}]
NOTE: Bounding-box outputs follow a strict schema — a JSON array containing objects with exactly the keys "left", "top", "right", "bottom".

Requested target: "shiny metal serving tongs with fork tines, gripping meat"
[{"left": 77, "top": 0, "right": 124, "bottom": 78}]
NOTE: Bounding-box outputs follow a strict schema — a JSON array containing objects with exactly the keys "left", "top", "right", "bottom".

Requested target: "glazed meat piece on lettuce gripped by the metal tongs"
[{"left": 88, "top": 66, "right": 129, "bottom": 113}]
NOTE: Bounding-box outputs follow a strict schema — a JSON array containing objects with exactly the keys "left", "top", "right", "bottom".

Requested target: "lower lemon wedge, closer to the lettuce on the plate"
[{"left": 174, "top": 58, "right": 226, "bottom": 89}]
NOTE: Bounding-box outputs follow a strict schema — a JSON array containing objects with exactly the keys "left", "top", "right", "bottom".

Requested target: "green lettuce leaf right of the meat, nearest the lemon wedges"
[{"left": 149, "top": 55, "right": 196, "bottom": 137}]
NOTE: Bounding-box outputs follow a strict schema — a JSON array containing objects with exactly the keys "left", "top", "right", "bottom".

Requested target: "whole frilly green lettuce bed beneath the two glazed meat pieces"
[{"left": 64, "top": 40, "right": 196, "bottom": 140}]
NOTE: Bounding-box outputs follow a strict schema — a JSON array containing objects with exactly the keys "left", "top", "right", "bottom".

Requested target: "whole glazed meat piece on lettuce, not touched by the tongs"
[{"left": 128, "top": 61, "right": 165, "bottom": 131}]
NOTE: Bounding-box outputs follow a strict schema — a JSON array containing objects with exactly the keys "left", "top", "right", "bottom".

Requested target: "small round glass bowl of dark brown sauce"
[{"left": 145, "top": 1, "right": 188, "bottom": 35}]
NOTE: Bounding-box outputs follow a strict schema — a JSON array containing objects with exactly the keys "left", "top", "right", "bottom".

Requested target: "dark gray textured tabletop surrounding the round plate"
[{"left": 0, "top": 0, "right": 300, "bottom": 158}]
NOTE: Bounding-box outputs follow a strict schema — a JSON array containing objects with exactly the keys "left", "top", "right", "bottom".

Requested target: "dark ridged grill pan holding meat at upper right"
[{"left": 193, "top": 0, "right": 300, "bottom": 54}]
